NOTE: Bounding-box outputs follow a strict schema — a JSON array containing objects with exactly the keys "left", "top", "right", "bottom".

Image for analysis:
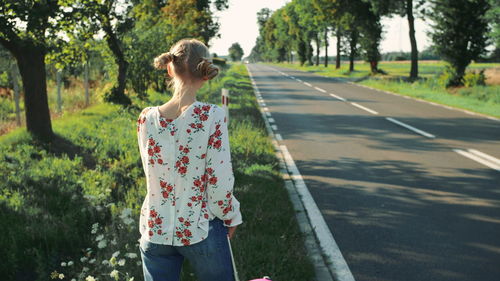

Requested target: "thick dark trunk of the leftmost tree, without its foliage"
[{"left": 14, "top": 47, "right": 54, "bottom": 141}]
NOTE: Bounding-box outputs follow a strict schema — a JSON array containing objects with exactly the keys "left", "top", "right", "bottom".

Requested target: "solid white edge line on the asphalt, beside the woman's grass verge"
[{"left": 280, "top": 145, "right": 354, "bottom": 281}]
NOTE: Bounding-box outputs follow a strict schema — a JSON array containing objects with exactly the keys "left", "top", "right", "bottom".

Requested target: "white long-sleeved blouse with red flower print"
[{"left": 137, "top": 101, "right": 242, "bottom": 246}]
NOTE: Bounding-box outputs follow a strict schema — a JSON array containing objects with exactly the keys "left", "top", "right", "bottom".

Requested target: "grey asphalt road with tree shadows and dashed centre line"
[{"left": 248, "top": 64, "right": 500, "bottom": 281}]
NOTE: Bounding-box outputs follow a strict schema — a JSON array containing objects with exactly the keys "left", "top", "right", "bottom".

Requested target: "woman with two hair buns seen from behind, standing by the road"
[{"left": 137, "top": 39, "right": 242, "bottom": 281}]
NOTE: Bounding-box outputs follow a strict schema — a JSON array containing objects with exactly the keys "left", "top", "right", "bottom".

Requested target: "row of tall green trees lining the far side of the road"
[{"left": 249, "top": 0, "right": 500, "bottom": 86}]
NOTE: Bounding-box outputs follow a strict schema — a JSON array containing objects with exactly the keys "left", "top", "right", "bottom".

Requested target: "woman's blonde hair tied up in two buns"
[{"left": 154, "top": 39, "right": 219, "bottom": 101}]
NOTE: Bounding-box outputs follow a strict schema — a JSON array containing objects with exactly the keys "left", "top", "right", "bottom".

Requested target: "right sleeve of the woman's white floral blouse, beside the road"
[{"left": 206, "top": 107, "right": 242, "bottom": 226}]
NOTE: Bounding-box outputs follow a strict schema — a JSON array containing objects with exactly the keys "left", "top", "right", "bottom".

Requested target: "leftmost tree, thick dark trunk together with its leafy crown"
[{"left": 0, "top": 0, "right": 75, "bottom": 141}]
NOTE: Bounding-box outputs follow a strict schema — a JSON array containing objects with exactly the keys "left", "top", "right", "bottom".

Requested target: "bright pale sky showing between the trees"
[{"left": 210, "top": 0, "right": 430, "bottom": 57}]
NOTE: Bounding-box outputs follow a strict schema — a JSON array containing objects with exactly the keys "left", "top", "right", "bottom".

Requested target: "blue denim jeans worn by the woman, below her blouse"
[{"left": 139, "top": 218, "right": 234, "bottom": 281}]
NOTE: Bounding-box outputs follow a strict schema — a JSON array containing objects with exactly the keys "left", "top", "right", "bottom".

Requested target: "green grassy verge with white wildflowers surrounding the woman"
[{"left": 0, "top": 64, "right": 314, "bottom": 281}]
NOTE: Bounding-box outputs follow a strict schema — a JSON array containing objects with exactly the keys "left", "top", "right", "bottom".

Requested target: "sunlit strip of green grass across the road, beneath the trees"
[{"left": 270, "top": 61, "right": 500, "bottom": 117}]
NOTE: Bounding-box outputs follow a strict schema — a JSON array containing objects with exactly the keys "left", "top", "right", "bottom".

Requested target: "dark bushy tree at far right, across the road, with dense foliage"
[{"left": 428, "top": 0, "right": 490, "bottom": 87}]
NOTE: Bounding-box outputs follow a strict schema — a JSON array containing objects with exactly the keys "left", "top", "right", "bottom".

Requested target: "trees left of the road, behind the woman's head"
[{"left": 0, "top": 0, "right": 228, "bottom": 141}]
